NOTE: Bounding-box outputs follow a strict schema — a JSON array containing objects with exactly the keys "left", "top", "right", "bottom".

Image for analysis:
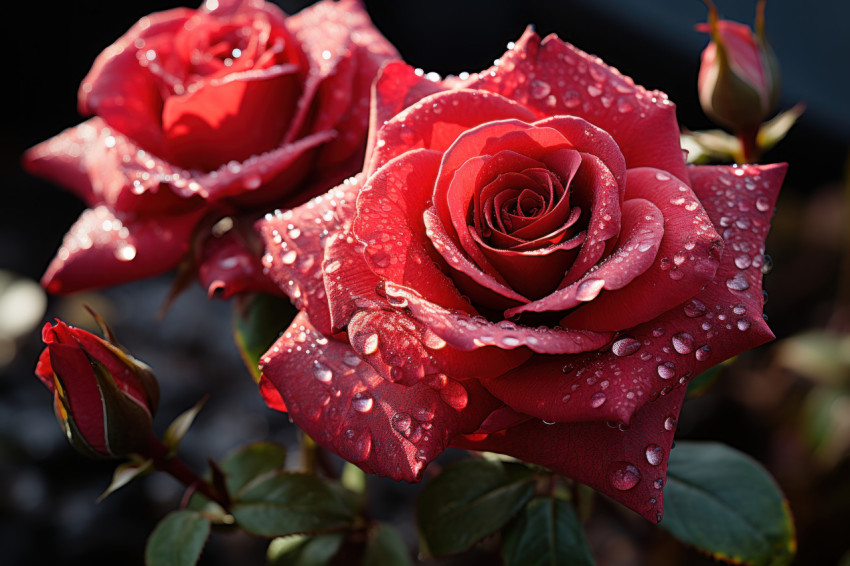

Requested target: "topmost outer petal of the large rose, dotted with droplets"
[{"left": 462, "top": 29, "right": 688, "bottom": 184}]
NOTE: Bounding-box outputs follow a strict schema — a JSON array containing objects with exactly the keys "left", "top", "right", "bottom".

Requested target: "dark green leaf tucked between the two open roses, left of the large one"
[{"left": 233, "top": 293, "right": 298, "bottom": 382}]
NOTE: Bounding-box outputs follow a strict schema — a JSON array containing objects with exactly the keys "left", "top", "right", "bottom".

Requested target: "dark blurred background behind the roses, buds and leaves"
[{"left": 0, "top": 0, "right": 850, "bottom": 565}]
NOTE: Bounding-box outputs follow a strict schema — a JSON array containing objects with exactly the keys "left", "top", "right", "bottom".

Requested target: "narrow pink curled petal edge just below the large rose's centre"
[{"left": 385, "top": 282, "right": 612, "bottom": 358}]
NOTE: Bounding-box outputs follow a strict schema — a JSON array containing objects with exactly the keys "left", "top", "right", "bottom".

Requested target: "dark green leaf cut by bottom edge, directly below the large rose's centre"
[{"left": 502, "top": 497, "right": 595, "bottom": 566}]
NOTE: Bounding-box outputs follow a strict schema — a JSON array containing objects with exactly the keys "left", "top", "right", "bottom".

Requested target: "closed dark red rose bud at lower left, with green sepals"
[{"left": 35, "top": 319, "right": 159, "bottom": 458}]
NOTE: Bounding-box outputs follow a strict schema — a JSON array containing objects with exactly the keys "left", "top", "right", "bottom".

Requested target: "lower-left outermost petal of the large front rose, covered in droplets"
[{"left": 262, "top": 313, "right": 498, "bottom": 481}]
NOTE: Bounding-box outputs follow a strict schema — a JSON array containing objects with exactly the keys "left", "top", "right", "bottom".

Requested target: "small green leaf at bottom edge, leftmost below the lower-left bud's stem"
[{"left": 145, "top": 510, "right": 210, "bottom": 566}]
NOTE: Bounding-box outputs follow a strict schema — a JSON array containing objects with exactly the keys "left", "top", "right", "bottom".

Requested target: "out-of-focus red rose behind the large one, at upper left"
[{"left": 25, "top": 0, "right": 397, "bottom": 300}]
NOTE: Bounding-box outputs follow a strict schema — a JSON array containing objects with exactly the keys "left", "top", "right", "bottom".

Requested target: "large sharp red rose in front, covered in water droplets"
[{"left": 259, "top": 27, "right": 785, "bottom": 521}]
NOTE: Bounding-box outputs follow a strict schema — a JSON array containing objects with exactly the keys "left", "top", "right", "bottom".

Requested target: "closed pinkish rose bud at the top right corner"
[{"left": 697, "top": 0, "right": 779, "bottom": 133}]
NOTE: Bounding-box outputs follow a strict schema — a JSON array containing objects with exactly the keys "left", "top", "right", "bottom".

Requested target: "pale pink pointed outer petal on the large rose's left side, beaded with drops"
[{"left": 256, "top": 176, "right": 363, "bottom": 335}]
